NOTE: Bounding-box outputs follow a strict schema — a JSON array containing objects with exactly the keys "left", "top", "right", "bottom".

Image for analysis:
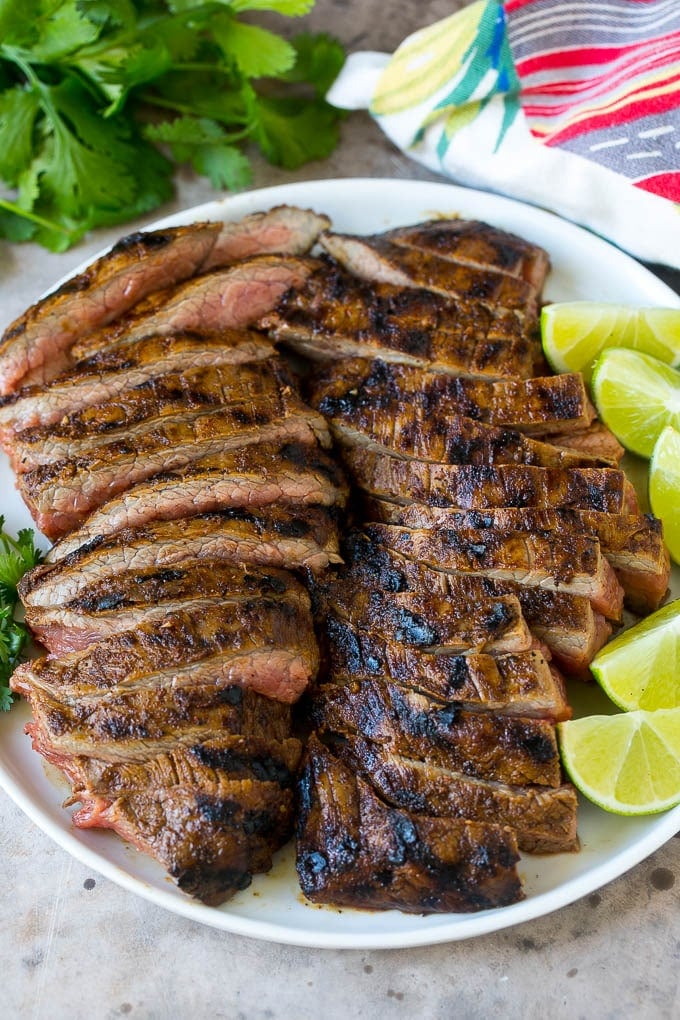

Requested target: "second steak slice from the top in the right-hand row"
[{"left": 319, "top": 233, "right": 536, "bottom": 320}]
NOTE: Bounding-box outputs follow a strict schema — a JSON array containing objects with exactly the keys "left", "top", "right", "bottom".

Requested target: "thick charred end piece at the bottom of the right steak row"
[{"left": 297, "top": 736, "right": 523, "bottom": 914}]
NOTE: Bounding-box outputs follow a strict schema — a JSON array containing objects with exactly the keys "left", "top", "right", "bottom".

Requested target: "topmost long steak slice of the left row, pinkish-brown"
[{"left": 0, "top": 208, "right": 328, "bottom": 396}]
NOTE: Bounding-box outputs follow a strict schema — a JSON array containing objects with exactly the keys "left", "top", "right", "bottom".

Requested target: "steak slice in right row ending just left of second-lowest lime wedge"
[{"left": 342, "top": 531, "right": 612, "bottom": 674}]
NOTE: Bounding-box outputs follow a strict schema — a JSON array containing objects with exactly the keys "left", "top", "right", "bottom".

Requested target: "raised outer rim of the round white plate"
[{"left": 0, "top": 177, "right": 680, "bottom": 950}]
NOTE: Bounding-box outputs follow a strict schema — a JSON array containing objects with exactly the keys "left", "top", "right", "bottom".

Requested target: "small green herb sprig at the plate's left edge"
[{"left": 0, "top": 515, "right": 43, "bottom": 712}]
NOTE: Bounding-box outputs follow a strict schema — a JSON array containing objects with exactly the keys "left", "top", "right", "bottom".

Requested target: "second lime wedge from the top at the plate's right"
[{"left": 591, "top": 347, "right": 680, "bottom": 457}]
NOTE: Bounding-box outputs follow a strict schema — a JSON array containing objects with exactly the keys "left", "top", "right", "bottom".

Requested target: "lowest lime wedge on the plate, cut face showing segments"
[{"left": 558, "top": 708, "right": 680, "bottom": 815}]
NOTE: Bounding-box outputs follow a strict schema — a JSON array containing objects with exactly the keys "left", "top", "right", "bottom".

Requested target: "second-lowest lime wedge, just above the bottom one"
[{"left": 590, "top": 595, "right": 680, "bottom": 712}]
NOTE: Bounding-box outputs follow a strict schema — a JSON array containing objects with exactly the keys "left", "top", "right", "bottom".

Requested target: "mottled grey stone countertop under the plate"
[{"left": 0, "top": 0, "right": 680, "bottom": 1020}]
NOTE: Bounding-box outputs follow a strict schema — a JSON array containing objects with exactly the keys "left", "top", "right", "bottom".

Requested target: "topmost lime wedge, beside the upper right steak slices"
[{"left": 540, "top": 301, "right": 680, "bottom": 379}]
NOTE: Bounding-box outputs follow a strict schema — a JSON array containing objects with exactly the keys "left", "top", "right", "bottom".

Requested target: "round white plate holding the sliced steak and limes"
[{"left": 0, "top": 180, "right": 680, "bottom": 949}]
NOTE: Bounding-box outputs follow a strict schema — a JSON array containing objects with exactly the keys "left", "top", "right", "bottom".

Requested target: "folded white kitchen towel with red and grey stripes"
[{"left": 328, "top": 0, "right": 680, "bottom": 268}]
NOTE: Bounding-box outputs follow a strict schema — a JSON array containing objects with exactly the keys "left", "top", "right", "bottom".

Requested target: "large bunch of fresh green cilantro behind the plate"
[{"left": 0, "top": 0, "right": 344, "bottom": 251}]
